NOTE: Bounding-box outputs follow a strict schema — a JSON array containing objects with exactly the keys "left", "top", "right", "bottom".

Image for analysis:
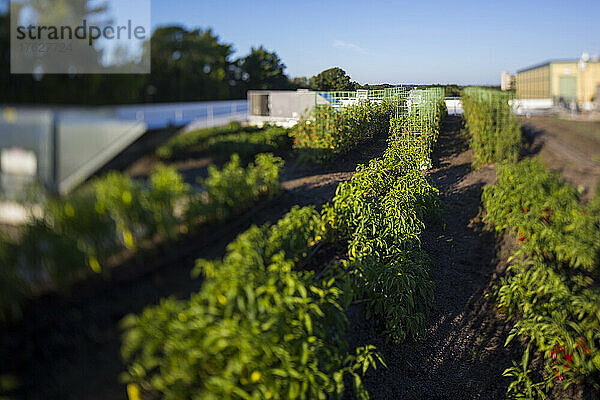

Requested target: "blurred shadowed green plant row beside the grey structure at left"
[{"left": 0, "top": 154, "right": 283, "bottom": 318}]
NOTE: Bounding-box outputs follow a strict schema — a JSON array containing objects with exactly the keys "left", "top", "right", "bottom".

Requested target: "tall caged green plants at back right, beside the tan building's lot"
[{"left": 461, "top": 87, "right": 521, "bottom": 167}]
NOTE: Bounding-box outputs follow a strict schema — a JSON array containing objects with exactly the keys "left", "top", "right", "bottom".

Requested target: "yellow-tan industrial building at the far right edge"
[{"left": 516, "top": 59, "right": 600, "bottom": 107}]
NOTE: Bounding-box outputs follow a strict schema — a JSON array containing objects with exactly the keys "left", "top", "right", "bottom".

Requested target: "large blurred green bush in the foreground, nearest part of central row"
[{"left": 122, "top": 208, "right": 380, "bottom": 399}]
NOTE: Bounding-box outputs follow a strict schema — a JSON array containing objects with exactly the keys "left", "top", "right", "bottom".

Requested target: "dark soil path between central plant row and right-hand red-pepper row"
[{"left": 350, "top": 117, "right": 518, "bottom": 400}]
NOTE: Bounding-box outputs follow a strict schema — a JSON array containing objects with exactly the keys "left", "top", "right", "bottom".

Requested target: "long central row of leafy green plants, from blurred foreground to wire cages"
[{"left": 122, "top": 95, "right": 446, "bottom": 399}]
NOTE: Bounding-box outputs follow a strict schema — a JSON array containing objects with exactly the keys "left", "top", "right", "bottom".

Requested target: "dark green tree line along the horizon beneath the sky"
[{"left": 0, "top": 5, "right": 460, "bottom": 105}]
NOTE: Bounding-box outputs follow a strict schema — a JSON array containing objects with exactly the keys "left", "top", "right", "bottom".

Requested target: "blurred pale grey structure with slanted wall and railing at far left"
[{"left": 0, "top": 100, "right": 248, "bottom": 196}]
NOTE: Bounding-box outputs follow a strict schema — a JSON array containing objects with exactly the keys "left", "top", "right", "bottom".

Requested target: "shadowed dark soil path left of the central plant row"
[{"left": 0, "top": 130, "right": 386, "bottom": 400}]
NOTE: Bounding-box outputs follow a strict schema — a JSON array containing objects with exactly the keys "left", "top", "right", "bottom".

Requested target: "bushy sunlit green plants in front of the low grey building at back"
[{"left": 290, "top": 101, "right": 393, "bottom": 161}]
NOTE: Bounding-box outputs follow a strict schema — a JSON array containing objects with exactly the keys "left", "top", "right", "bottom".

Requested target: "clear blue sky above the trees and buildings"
[{"left": 152, "top": 0, "right": 600, "bottom": 84}]
